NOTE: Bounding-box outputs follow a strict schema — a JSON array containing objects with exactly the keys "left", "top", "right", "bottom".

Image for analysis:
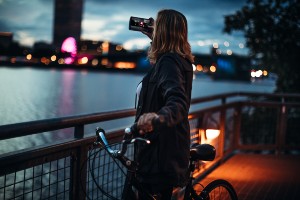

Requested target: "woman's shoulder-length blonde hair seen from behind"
[{"left": 148, "top": 9, "right": 194, "bottom": 63}]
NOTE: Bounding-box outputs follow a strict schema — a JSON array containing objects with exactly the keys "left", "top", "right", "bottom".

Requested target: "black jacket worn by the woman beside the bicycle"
[{"left": 136, "top": 53, "right": 193, "bottom": 187}]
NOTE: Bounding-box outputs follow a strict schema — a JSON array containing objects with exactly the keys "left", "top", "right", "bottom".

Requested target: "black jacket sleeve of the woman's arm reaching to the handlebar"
[{"left": 157, "top": 56, "right": 189, "bottom": 127}]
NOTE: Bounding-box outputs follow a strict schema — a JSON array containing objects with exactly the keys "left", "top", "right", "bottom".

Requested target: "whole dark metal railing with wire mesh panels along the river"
[{"left": 0, "top": 92, "right": 300, "bottom": 199}]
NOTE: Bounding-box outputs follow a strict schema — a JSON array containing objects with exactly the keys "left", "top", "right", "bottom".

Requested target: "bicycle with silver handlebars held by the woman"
[{"left": 88, "top": 126, "right": 238, "bottom": 200}]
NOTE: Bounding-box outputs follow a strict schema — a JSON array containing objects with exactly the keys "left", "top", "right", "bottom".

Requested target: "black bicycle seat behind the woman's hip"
[{"left": 190, "top": 144, "right": 216, "bottom": 161}]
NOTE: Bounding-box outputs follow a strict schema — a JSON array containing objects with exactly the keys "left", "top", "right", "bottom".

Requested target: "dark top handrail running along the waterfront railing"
[{"left": 0, "top": 92, "right": 300, "bottom": 140}]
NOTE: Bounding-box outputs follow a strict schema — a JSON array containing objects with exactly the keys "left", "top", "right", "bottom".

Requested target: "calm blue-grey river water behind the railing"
[{"left": 0, "top": 66, "right": 275, "bottom": 154}]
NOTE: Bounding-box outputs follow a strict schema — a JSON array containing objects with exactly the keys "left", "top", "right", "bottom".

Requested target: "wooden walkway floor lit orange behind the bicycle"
[{"left": 200, "top": 154, "right": 300, "bottom": 200}]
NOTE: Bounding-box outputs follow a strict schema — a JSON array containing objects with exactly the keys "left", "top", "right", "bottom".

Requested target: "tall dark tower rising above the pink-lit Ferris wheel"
[{"left": 53, "top": 0, "right": 83, "bottom": 47}]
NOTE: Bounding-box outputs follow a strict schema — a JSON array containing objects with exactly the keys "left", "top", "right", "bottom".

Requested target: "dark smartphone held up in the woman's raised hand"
[{"left": 129, "top": 17, "right": 154, "bottom": 33}]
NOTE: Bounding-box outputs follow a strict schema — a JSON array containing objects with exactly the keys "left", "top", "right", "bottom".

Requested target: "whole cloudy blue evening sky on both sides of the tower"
[{"left": 0, "top": 0, "right": 248, "bottom": 54}]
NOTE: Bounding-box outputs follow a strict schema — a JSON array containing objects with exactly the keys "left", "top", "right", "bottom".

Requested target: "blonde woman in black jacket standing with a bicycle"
[{"left": 136, "top": 10, "right": 193, "bottom": 199}]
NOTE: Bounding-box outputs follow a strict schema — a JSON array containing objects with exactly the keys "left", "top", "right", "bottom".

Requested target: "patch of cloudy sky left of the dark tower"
[{"left": 0, "top": 0, "right": 53, "bottom": 46}]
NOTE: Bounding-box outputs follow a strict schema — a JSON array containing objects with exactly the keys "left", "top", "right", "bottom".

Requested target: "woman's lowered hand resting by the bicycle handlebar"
[{"left": 137, "top": 113, "right": 159, "bottom": 135}]
